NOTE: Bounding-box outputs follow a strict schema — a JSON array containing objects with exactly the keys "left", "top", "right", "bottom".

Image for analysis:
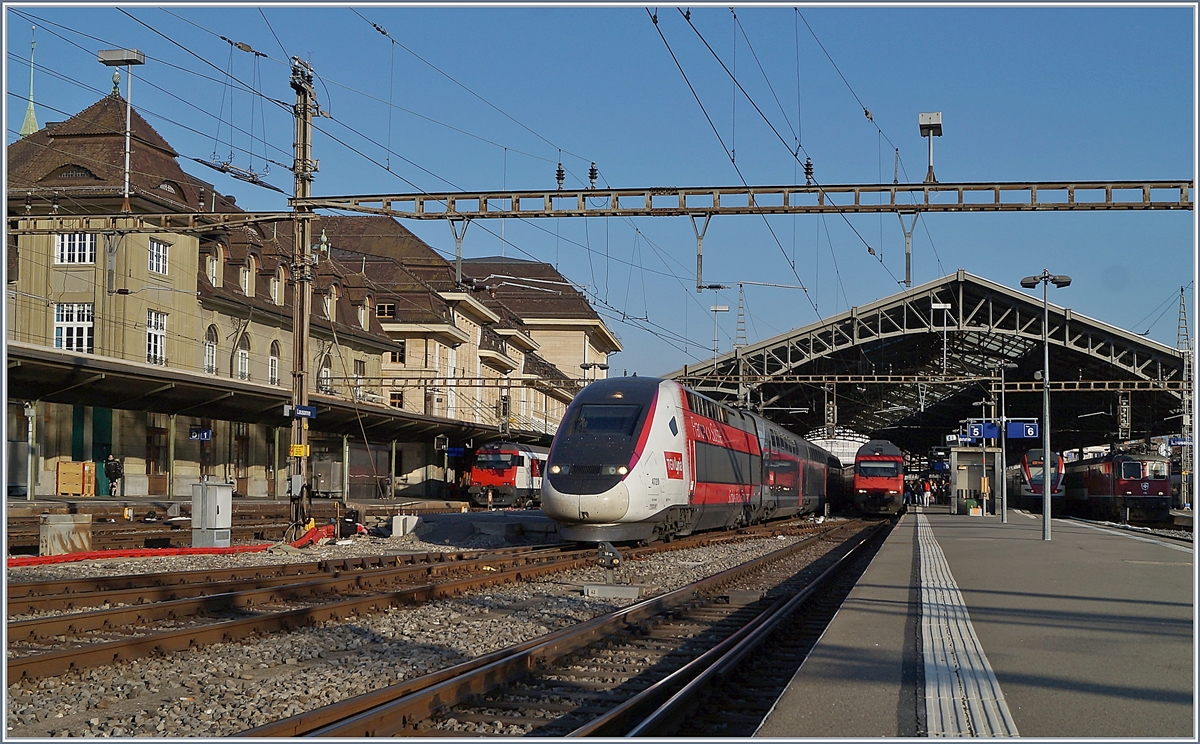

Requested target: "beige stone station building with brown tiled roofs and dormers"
[{"left": 6, "top": 91, "right": 620, "bottom": 498}]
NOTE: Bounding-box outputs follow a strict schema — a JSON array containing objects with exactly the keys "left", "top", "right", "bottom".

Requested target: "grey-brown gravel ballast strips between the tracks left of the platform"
[{"left": 6, "top": 523, "right": 828, "bottom": 737}]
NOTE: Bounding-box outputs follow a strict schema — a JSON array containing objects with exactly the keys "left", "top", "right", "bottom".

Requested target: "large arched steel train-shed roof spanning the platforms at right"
[{"left": 666, "top": 270, "right": 1184, "bottom": 455}]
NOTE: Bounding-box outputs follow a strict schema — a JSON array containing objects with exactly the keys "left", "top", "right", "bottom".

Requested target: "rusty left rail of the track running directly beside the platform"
[{"left": 243, "top": 522, "right": 862, "bottom": 737}]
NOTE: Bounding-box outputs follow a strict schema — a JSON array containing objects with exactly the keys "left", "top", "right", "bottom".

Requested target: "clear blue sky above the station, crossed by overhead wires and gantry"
[{"left": 5, "top": 5, "right": 1198, "bottom": 374}]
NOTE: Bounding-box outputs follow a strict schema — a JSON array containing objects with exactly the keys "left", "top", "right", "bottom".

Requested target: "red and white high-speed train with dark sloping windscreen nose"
[{"left": 541, "top": 377, "right": 832, "bottom": 542}]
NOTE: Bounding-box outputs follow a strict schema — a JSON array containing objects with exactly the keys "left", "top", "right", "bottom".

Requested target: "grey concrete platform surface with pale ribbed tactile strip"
[{"left": 756, "top": 506, "right": 1196, "bottom": 740}]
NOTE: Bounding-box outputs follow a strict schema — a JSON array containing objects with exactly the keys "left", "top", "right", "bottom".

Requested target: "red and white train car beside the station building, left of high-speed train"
[{"left": 467, "top": 442, "right": 550, "bottom": 508}]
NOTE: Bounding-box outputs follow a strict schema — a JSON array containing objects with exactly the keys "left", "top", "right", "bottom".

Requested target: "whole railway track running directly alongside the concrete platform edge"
[{"left": 242, "top": 522, "right": 887, "bottom": 737}]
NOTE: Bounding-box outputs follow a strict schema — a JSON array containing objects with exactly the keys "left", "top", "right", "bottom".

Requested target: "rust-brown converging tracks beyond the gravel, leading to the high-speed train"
[{"left": 7, "top": 523, "right": 844, "bottom": 679}]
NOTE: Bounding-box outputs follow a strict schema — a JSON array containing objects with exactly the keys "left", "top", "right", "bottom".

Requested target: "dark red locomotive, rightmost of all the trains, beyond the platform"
[{"left": 1064, "top": 452, "right": 1171, "bottom": 522}]
